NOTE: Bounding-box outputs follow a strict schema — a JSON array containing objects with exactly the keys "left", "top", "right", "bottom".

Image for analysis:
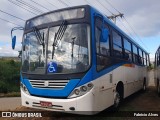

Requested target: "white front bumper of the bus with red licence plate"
[{"left": 21, "top": 90, "right": 97, "bottom": 114}]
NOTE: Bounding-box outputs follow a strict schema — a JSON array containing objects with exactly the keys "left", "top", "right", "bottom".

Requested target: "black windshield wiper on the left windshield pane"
[{"left": 33, "top": 27, "right": 45, "bottom": 54}]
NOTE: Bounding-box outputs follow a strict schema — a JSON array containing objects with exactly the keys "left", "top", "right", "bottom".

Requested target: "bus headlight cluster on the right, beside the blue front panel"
[{"left": 68, "top": 83, "right": 93, "bottom": 98}]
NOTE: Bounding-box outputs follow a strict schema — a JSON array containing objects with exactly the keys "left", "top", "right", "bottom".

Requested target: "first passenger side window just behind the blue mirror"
[{"left": 112, "top": 31, "right": 123, "bottom": 58}]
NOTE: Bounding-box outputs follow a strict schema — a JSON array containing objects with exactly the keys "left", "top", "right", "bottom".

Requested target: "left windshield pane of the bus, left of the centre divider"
[{"left": 22, "top": 29, "right": 47, "bottom": 74}]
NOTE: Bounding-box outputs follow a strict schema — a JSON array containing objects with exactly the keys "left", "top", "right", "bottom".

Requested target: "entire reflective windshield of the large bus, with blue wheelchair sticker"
[{"left": 22, "top": 23, "right": 90, "bottom": 74}]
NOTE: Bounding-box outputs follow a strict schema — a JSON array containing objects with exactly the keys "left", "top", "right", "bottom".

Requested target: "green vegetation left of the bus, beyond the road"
[{"left": 0, "top": 59, "right": 21, "bottom": 93}]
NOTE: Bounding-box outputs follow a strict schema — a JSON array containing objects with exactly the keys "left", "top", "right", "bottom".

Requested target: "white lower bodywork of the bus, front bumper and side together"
[{"left": 21, "top": 65, "right": 147, "bottom": 114}]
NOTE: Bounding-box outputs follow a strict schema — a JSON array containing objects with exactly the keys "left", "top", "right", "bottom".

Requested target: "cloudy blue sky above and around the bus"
[{"left": 0, "top": 0, "right": 160, "bottom": 61}]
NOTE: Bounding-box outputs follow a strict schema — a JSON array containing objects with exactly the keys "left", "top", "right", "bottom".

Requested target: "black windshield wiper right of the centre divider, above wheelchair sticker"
[{"left": 52, "top": 20, "right": 67, "bottom": 59}]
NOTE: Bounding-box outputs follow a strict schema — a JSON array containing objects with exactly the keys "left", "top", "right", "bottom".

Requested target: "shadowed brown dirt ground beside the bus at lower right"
[{"left": 120, "top": 86, "right": 160, "bottom": 111}]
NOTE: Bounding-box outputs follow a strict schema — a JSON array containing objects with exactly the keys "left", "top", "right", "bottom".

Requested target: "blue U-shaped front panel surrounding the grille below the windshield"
[{"left": 23, "top": 79, "right": 80, "bottom": 97}]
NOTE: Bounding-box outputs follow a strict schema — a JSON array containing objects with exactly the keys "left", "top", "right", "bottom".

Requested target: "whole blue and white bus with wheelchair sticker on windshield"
[{"left": 13, "top": 5, "right": 149, "bottom": 114}]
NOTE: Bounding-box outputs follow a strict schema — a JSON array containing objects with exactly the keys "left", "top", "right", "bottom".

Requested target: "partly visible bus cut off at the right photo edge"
[{"left": 154, "top": 46, "right": 160, "bottom": 96}]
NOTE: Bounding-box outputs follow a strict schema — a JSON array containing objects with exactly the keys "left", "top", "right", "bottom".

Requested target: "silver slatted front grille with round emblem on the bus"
[{"left": 29, "top": 80, "right": 69, "bottom": 89}]
